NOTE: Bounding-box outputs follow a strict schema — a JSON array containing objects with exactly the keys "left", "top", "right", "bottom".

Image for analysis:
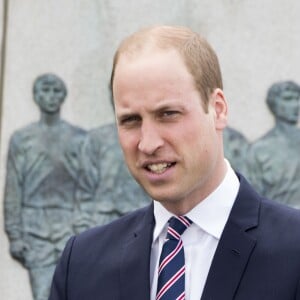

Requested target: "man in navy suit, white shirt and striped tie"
[{"left": 50, "top": 26, "right": 300, "bottom": 300}]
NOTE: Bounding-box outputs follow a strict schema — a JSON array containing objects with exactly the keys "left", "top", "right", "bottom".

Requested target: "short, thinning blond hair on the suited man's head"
[{"left": 110, "top": 25, "right": 223, "bottom": 109}]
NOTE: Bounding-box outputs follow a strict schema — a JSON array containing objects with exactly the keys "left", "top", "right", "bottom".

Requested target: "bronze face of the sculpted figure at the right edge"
[{"left": 275, "top": 90, "right": 300, "bottom": 124}]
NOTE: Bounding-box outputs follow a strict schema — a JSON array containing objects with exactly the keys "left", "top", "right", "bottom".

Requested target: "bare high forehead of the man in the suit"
[{"left": 113, "top": 50, "right": 200, "bottom": 116}]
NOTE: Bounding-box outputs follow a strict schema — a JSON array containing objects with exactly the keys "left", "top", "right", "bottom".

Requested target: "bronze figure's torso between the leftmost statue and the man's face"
[{"left": 76, "top": 123, "right": 150, "bottom": 231}]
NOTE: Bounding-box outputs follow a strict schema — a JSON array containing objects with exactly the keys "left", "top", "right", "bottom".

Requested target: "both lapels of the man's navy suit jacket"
[{"left": 120, "top": 174, "right": 260, "bottom": 300}]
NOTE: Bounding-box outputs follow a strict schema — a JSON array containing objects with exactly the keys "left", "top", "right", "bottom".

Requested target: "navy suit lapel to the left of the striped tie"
[{"left": 120, "top": 204, "right": 154, "bottom": 300}]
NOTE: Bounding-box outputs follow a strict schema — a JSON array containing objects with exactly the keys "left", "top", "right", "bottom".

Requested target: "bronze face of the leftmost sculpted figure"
[{"left": 35, "top": 80, "right": 65, "bottom": 114}]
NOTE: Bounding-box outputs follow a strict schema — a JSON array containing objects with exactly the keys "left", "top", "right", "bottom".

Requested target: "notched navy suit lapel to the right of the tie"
[{"left": 201, "top": 177, "right": 260, "bottom": 300}]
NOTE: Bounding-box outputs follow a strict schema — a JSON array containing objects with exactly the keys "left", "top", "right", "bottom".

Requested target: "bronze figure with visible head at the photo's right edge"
[{"left": 247, "top": 81, "right": 300, "bottom": 208}]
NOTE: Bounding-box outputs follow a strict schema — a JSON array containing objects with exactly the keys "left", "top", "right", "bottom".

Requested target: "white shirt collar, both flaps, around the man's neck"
[{"left": 153, "top": 160, "right": 240, "bottom": 242}]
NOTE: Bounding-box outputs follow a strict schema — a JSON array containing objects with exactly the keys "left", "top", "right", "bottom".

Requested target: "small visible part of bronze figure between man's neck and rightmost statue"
[{"left": 223, "top": 127, "right": 249, "bottom": 171}]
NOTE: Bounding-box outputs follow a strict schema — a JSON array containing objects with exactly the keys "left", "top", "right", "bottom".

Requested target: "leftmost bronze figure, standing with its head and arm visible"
[{"left": 4, "top": 74, "right": 85, "bottom": 300}]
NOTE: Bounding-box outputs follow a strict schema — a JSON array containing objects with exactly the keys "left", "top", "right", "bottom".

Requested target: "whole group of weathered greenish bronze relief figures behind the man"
[{"left": 4, "top": 74, "right": 300, "bottom": 300}]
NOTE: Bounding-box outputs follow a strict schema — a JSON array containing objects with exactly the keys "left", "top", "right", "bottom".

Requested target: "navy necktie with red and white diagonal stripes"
[{"left": 156, "top": 216, "right": 192, "bottom": 300}]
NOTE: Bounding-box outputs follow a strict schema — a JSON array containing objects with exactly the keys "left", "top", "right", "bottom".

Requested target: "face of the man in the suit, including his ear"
[{"left": 113, "top": 49, "right": 227, "bottom": 213}]
